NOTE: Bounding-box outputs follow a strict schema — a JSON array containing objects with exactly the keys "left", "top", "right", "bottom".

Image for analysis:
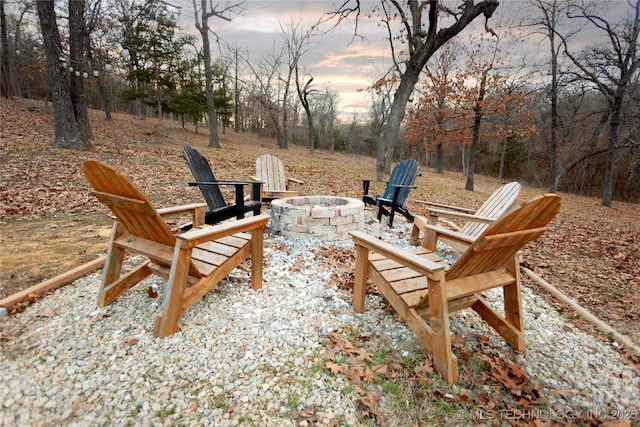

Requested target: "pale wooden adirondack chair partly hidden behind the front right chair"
[{"left": 409, "top": 182, "right": 520, "bottom": 252}]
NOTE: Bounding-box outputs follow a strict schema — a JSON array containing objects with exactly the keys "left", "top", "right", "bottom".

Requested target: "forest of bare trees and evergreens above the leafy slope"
[{"left": 0, "top": 0, "right": 640, "bottom": 206}]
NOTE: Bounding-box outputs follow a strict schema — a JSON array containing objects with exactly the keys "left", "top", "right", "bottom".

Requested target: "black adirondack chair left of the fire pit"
[{"left": 182, "top": 145, "right": 262, "bottom": 231}]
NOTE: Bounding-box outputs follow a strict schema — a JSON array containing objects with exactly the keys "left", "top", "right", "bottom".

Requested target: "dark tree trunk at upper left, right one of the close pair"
[{"left": 69, "top": 0, "right": 93, "bottom": 145}]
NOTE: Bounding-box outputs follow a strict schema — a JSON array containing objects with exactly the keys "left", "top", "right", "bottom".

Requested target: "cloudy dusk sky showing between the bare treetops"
[{"left": 171, "top": 0, "right": 628, "bottom": 118}]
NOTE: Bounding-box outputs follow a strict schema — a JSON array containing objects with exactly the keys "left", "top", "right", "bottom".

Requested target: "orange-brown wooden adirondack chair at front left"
[{"left": 84, "top": 160, "right": 269, "bottom": 337}]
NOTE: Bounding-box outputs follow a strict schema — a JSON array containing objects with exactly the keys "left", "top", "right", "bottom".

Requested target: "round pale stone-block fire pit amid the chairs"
[{"left": 271, "top": 196, "right": 364, "bottom": 241}]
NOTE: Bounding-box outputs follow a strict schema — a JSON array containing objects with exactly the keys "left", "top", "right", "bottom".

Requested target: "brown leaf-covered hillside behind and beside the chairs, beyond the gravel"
[{"left": 0, "top": 99, "right": 640, "bottom": 343}]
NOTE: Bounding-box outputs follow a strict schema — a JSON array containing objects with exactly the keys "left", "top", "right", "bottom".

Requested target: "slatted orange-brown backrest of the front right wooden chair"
[{"left": 446, "top": 194, "right": 560, "bottom": 280}]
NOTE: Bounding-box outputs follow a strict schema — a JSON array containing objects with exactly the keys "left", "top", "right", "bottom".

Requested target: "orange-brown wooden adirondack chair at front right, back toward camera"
[{"left": 349, "top": 194, "right": 560, "bottom": 384}]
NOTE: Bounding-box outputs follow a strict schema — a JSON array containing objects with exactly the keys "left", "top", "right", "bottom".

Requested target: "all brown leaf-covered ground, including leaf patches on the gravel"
[{"left": 0, "top": 100, "right": 640, "bottom": 425}]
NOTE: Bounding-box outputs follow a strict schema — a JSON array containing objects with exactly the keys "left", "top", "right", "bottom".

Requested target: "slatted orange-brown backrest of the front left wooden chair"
[{"left": 84, "top": 160, "right": 176, "bottom": 247}]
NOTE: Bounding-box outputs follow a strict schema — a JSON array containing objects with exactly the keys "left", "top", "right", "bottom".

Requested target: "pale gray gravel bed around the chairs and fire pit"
[{"left": 0, "top": 213, "right": 640, "bottom": 426}]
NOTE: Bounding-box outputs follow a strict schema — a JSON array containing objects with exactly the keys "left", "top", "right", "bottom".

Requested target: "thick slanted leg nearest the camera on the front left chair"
[{"left": 154, "top": 245, "right": 193, "bottom": 338}]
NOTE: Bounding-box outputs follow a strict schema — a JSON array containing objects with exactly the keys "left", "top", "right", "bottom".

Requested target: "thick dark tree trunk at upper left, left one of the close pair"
[{"left": 36, "top": 0, "right": 90, "bottom": 150}]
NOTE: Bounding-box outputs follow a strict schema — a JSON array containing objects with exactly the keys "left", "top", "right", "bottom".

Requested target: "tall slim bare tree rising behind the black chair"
[{"left": 192, "top": 0, "right": 244, "bottom": 148}]
